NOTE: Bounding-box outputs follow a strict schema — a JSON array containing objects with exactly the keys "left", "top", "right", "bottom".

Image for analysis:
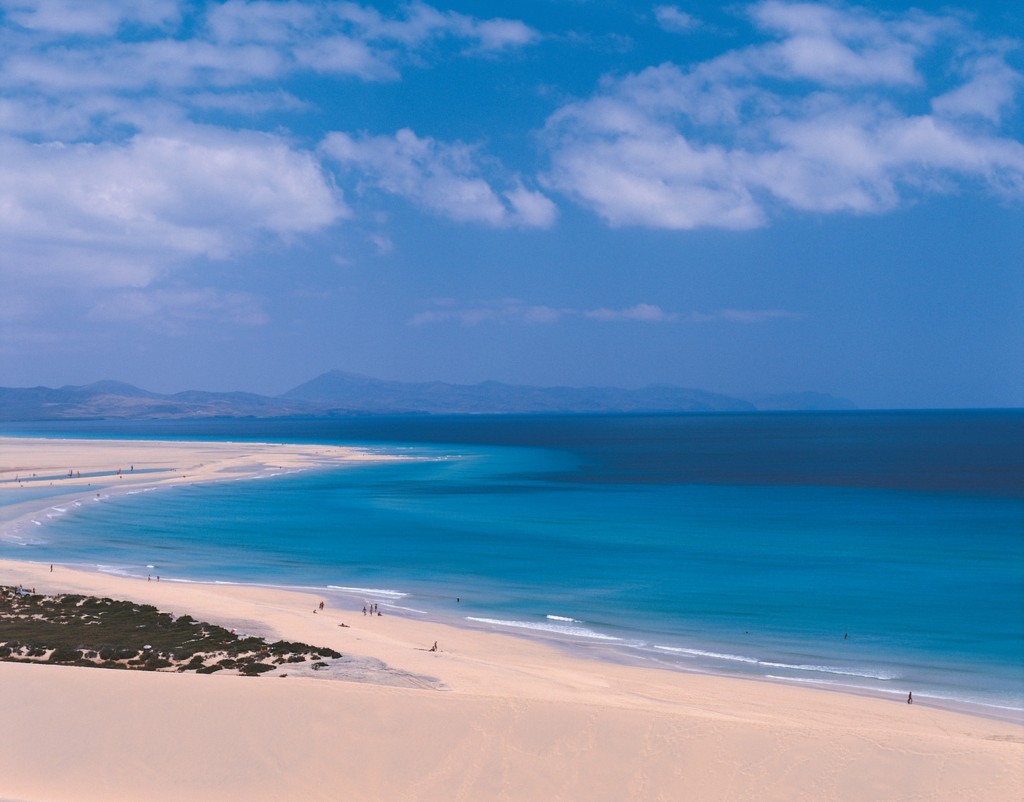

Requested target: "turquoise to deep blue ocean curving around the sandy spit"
[{"left": 0, "top": 411, "right": 1024, "bottom": 720}]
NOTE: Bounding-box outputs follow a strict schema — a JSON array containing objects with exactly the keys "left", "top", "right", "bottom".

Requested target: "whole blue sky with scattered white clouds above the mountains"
[{"left": 0, "top": 0, "right": 1024, "bottom": 408}]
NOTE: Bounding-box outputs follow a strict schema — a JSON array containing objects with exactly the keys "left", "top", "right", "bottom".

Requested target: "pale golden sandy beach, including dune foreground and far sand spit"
[{"left": 0, "top": 438, "right": 1024, "bottom": 800}]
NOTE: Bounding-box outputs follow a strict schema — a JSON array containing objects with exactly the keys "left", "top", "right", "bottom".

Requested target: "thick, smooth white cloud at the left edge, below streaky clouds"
[{"left": 0, "top": 129, "right": 347, "bottom": 286}]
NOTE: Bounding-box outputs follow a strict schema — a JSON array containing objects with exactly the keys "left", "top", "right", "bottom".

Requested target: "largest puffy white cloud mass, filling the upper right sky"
[{"left": 545, "top": 0, "right": 1024, "bottom": 229}]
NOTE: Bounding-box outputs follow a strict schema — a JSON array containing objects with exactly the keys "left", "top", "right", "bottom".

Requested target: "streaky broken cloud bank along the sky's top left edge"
[{"left": 0, "top": 0, "right": 540, "bottom": 108}]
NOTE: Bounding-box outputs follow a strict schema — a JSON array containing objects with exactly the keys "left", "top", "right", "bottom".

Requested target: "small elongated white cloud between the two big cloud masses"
[{"left": 321, "top": 128, "right": 556, "bottom": 227}]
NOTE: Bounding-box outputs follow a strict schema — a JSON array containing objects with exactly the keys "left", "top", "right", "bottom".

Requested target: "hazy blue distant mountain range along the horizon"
[{"left": 0, "top": 371, "right": 855, "bottom": 421}]
